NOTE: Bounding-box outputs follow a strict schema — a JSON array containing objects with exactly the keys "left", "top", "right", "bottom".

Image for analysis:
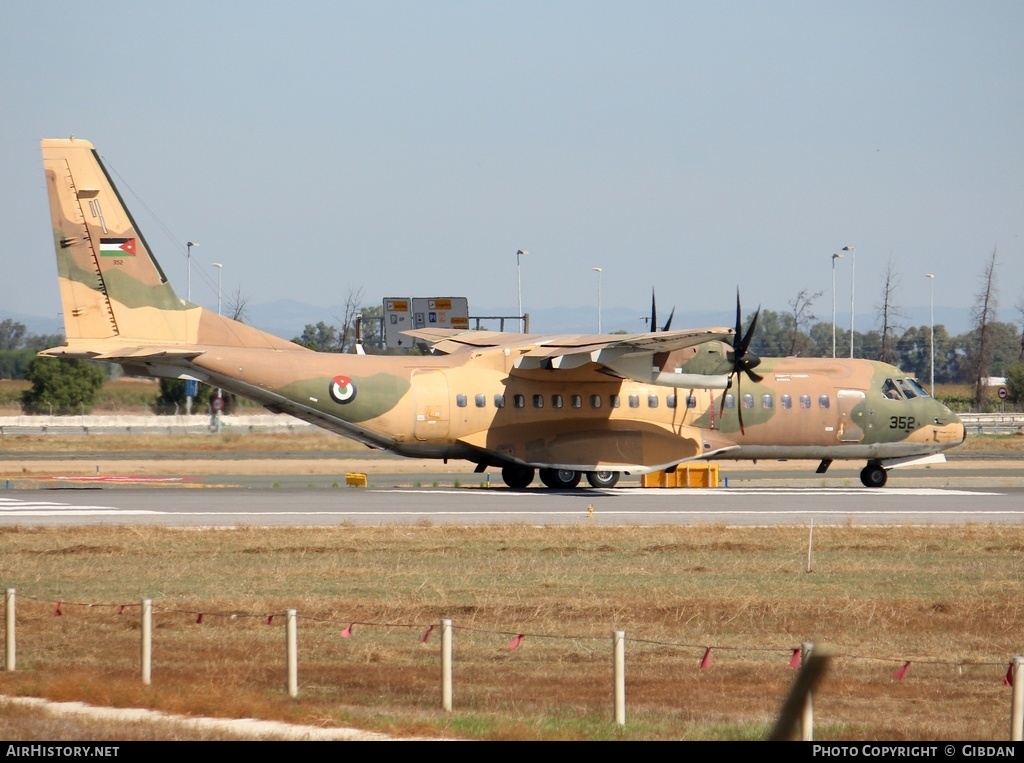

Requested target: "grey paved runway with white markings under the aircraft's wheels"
[{"left": 0, "top": 482, "right": 1024, "bottom": 526}]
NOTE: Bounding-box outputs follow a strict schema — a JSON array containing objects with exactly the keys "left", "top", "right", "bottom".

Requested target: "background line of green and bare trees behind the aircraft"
[{"left": 0, "top": 251, "right": 1024, "bottom": 414}]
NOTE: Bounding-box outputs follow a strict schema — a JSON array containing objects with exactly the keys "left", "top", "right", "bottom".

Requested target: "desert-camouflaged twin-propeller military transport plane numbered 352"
[{"left": 42, "top": 138, "right": 965, "bottom": 489}]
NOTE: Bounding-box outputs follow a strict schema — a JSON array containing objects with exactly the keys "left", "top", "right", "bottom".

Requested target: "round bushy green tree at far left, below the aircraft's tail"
[{"left": 22, "top": 356, "right": 106, "bottom": 416}]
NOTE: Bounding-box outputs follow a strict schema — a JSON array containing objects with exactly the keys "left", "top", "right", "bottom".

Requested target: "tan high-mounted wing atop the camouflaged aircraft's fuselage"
[{"left": 403, "top": 327, "right": 735, "bottom": 389}]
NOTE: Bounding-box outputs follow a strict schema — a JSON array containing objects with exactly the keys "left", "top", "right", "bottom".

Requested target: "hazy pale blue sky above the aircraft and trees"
[{"left": 0, "top": 0, "right": 1024, "bottom": 330}]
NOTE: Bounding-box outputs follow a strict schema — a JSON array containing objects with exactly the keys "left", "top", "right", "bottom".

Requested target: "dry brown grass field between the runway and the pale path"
[{"left": 0, "top": 525, "right": 1024, "bottom": 739}]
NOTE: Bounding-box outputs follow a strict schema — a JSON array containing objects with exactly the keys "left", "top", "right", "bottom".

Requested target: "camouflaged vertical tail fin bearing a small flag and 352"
[{"left": 42, "top": 138, "right": 296, "bottom": 349}]
